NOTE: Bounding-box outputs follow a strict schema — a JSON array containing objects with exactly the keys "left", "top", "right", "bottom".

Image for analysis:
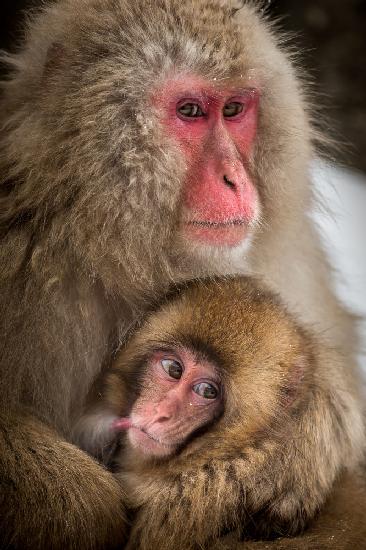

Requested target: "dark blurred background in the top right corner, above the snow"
[{"left": 270, "top": 0, "right": 366, "bottom": 172}]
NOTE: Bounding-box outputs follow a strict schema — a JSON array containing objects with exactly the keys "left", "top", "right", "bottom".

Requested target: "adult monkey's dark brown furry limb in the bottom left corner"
[{"left": 0, "top": 412, "right": 126, "bottom": 550}]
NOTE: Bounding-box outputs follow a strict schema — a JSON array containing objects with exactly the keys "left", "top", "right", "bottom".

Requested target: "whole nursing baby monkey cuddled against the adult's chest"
[{"left": 78, "top": 277, "right": 354, "bottom": 550}]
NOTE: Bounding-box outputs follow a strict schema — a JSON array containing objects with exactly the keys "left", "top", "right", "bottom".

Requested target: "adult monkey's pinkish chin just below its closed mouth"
[{"left": 183, "top": 220, "right": 248, "bottom": 247}]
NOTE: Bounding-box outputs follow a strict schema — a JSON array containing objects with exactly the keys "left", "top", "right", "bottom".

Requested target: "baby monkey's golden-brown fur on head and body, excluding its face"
[{"left": 80, "top": 277, "right": 354, "bottom": 550}]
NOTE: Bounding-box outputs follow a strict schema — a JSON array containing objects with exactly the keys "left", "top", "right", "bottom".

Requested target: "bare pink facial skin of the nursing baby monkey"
[{"left": 113, "top": 349, "right": 222, "bottom": 458}]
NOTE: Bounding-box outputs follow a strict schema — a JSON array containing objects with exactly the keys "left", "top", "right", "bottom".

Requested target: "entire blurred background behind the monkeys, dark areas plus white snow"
[{"left": 0, "top": 0, "right": 366, "bottom": 372}]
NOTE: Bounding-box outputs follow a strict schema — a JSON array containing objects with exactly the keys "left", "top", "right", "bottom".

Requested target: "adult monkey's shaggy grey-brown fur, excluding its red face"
[{"left": 0, "top": 0, "right": 364, "bottom": 548}]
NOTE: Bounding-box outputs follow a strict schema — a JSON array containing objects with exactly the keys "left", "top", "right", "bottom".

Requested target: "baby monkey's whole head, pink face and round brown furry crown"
[{"left": 104, "top": 277, "right": 313, "bottom": 461}]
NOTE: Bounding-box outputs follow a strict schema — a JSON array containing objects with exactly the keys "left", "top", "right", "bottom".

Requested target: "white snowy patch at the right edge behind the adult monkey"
[{"left": 312, "top": 162, "right": 366, "bottom": 379}]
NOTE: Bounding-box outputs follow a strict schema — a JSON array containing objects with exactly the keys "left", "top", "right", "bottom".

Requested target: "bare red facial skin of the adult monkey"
[{"left": 153, "top": 76, "right": 259, "bottom": 246}]
